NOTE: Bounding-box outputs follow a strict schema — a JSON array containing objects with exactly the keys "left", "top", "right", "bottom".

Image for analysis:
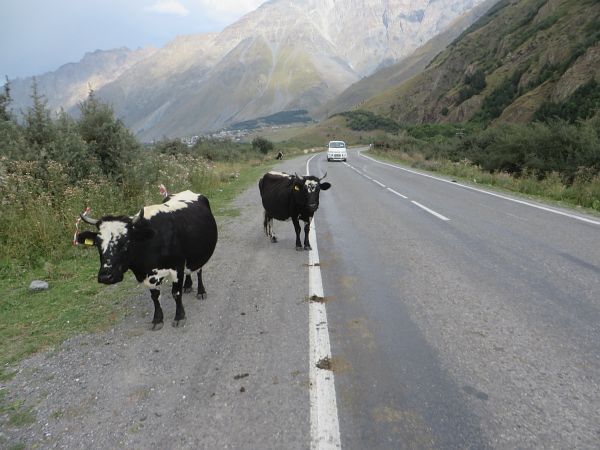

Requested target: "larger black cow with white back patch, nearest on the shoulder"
[{"left": 77, "top": 191, "right": 217, "bottom": 330}]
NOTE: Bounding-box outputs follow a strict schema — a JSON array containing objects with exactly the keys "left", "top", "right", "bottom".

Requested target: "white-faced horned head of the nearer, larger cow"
[{"left": 77, "top": 208, "right": 155, "bottom": 284}]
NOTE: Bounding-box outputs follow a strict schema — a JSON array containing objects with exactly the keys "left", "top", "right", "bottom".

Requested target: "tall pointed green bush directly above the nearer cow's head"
[{"left": 78, "top": 90, "right": 139, "bottom": 178}]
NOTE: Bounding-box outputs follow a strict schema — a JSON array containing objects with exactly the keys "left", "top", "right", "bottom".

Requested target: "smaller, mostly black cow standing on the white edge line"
[{"left": 258, "top": 172, "right": 331, "bottom": 250}]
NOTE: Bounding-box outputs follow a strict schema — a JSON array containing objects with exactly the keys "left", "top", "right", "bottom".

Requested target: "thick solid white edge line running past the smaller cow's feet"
[{"left": 306, "top": 155, "right": 341, "bottom": 450}]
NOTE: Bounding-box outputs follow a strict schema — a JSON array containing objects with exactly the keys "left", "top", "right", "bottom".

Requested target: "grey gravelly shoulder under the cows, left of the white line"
[{"left": 0, "top": 167, "right": 310, "bottom": 449}]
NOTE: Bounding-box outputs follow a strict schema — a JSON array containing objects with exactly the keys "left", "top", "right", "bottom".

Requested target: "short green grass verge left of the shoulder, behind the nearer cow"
[{"left": 0, "top": 158, "right": 272, "bottom": 436}]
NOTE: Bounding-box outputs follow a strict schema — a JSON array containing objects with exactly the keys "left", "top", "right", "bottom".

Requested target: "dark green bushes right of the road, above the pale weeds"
[{"left": 374, "top": 115, "right": 600, "bottom": 186}]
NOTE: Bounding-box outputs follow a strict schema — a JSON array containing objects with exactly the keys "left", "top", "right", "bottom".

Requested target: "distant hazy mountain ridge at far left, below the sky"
[{"left": 10, "top": 48, "right": 156, "bottom": 116}]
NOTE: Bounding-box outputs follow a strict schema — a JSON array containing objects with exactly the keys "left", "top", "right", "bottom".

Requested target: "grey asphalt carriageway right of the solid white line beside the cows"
[{"left": 311, "top": 150, "right": 600, "bottom": 449}]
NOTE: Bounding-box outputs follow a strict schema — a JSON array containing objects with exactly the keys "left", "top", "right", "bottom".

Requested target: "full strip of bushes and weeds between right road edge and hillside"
[{"left": 374, "top": 115, "right": 600, "bottom": 211}]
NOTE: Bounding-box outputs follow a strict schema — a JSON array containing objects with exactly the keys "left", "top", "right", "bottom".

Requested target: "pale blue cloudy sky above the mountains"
[{"left": 0, "top": 0, "right": 265, "bottom": 79}]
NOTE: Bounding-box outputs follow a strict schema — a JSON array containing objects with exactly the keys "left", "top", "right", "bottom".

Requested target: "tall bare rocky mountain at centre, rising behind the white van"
[{"left": 8, "top": 0, "right": 492, "bottom": 140}]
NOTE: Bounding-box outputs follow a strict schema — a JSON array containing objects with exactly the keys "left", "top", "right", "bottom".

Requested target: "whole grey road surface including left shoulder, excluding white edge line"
[{"left": 0, "top": 150, "right": 600, "bottom": 449}]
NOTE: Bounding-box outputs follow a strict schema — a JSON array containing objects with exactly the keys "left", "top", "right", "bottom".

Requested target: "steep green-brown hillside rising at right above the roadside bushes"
[{"left": 362, "top": 0, "right": 600, "bottom": 124}]
